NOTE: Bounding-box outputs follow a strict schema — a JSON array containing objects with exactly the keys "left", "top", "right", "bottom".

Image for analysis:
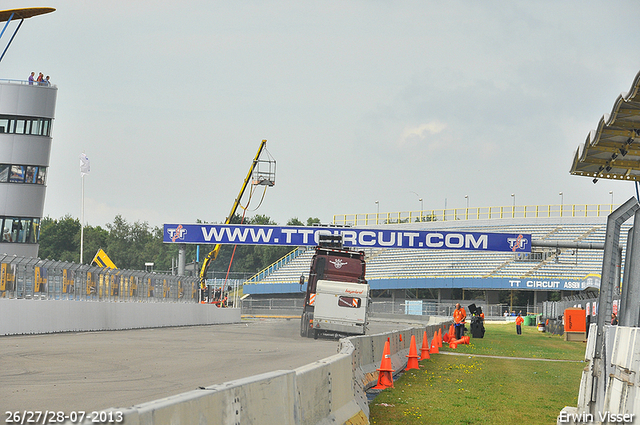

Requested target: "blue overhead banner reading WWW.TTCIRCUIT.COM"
[{"left": 163, "top": 224, "right": 531, "bottom": 252}]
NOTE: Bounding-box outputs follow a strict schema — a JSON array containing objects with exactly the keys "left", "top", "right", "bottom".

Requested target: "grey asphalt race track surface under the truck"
[{"left": 0, "top": 319, "right": 409, "bottom": 413}]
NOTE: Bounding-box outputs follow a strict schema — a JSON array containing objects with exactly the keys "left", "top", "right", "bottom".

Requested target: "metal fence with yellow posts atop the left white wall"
[{"left": 0, "top": 254, "right": 199, "bottom": 302}]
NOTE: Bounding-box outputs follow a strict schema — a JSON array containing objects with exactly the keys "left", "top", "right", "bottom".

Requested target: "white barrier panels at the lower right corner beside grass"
[{"left": 557, "top": 324, "right": 640, "bottom": 425}]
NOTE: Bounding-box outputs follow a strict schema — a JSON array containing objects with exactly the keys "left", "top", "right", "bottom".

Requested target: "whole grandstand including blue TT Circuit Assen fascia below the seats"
[{"left": 245, "top": 206, "right": 631, "bottom": 294}]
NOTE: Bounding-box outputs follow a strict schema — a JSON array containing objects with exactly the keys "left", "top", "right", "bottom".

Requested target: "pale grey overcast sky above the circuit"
[{"left": 0, "top": 0, "right": 640, "bottom": 226}]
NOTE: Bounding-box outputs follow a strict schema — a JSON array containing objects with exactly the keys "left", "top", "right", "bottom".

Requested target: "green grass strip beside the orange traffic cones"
[{"left": 370, "top": 324, "right": 585, "bottom": 425}]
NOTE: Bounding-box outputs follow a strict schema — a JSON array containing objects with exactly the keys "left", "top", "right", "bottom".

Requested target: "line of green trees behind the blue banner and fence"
[{"left": 38, "top": 214, "right": 320, "bottom": 277}]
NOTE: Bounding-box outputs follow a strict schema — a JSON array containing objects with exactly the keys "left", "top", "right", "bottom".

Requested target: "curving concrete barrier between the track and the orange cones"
[{"left": 85, "top": 320, "right": 450, "bottom": 425}]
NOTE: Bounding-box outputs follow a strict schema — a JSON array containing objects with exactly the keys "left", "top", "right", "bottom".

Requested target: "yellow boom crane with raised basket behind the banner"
[{"left": 200, "top": 140, "right": 276, "bottom": 290}]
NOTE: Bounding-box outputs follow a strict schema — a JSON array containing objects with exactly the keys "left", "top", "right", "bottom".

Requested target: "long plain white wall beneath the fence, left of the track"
[{"left": 0, "top": 298, "right": 240, "bottom": 335}]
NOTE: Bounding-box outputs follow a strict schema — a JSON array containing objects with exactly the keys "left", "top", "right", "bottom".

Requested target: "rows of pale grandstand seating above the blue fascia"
[{"left": 246, "top": 217, "right": 630, "bottom": 284}]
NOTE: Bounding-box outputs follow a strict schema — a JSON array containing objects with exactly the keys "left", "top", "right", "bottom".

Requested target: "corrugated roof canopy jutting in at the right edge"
[{"left": 571, "top": 72, "right": 640, "bottom": 183}]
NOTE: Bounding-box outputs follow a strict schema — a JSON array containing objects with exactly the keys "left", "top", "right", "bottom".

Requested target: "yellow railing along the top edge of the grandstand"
[{"left": 332, "top": 204, "right": 616, "bottom": 226}]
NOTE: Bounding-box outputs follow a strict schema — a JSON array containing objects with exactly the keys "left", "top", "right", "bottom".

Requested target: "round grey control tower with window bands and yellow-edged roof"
[{"left": 0, "top": 8, "right": 58, "bottom": 257}]
